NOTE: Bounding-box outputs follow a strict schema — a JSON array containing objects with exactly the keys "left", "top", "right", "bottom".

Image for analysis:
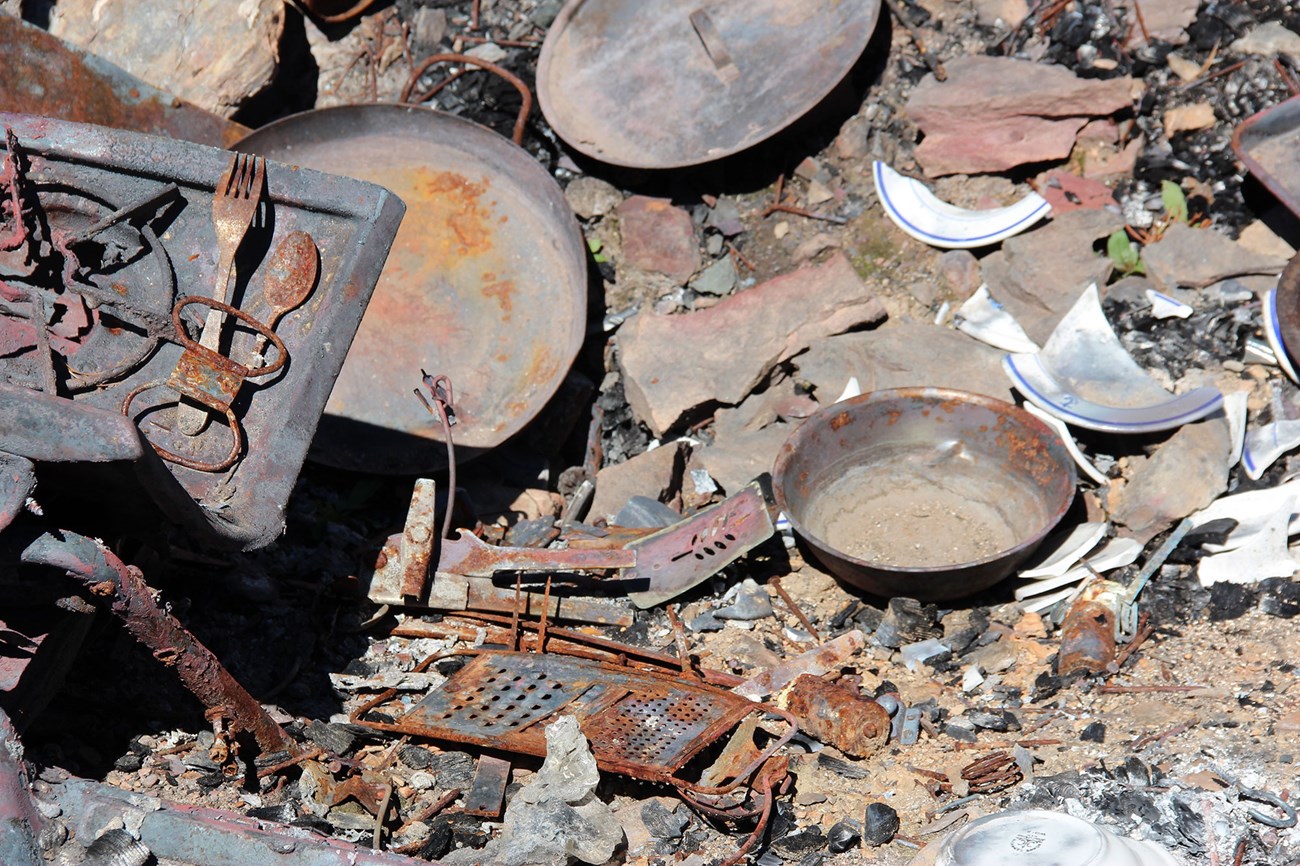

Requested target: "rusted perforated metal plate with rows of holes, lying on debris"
[{"left": 382, "top": 653, "right": 754, "bottom": 780}]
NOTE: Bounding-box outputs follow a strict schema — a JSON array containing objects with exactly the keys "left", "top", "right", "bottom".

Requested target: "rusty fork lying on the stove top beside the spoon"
[{"left": 177, "top": 153, "right": 267, "bottom": 436}]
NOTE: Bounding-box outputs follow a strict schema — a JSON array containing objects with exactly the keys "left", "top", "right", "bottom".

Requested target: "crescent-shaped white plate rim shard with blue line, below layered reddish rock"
[{"left": 872, "top": 161, "right": 1052, "bottom": 250}]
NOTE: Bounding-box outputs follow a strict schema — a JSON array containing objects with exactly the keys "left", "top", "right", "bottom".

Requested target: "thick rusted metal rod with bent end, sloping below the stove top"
[{"left": 22, "top": 532, "right": 302, "bottom": 754}]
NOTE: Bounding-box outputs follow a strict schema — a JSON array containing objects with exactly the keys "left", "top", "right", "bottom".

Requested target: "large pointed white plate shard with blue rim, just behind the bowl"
[{"left": 1002, "top": 283, "right": 1223, "bottom": 433}]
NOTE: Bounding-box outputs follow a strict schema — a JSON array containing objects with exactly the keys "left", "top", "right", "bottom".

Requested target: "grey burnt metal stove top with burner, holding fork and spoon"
[{"left": 0, "top": 113, "right": 403, "bottom": 549}]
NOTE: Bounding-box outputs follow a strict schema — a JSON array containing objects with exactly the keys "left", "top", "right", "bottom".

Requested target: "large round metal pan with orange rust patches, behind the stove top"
[{"left": 237, "top": 104, "right": 586, "bottom": 473}]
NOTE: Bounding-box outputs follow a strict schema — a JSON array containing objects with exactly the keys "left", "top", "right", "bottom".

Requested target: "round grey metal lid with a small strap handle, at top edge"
[{"left": 537, "top": 0, "right": 880, "bottom": 169}]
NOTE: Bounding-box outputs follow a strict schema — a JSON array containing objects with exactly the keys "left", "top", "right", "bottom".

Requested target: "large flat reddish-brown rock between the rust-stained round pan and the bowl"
[{"left": 618, "top": 252, "right": 885, "bottom": 436}]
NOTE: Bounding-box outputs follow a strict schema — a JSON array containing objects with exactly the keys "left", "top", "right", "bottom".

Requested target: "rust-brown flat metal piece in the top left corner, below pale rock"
[{"left": 0, "top": 14, "right": 248, "bottom": 147}]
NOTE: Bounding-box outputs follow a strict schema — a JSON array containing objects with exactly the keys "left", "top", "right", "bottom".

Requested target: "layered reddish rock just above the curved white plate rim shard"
[{"left": 906, "top": 56, "right": 1132, "bottom": 177}]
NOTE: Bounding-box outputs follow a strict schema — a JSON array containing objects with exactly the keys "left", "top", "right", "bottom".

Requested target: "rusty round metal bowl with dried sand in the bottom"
[{"left": 772, "top": 387, "right": 1075, "bottom": 601}]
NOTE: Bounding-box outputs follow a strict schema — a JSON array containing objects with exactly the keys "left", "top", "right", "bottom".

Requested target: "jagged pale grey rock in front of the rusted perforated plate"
[{"left": 485, "top": 715, "right": 623, "bottom": 866}]
